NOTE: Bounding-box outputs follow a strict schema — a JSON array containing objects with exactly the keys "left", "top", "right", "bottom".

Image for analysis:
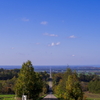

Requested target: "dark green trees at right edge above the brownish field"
[{"left": 79, "top": 73, "right": 100, "bottom": 93}]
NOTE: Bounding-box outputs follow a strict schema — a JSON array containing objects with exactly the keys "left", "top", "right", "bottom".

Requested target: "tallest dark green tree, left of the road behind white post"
[{"left": 15, "top": 61, "right": 42, "bottom": 100}]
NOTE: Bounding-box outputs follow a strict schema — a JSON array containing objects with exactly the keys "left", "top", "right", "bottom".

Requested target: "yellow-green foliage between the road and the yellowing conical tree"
[{"left": 53, "top": 68, "right": 73, "bottom": 99}]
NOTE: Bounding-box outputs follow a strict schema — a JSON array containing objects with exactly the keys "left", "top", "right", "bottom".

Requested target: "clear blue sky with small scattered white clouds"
[{"left": 0, "top": 0, "right": 100, "bottom": 65}]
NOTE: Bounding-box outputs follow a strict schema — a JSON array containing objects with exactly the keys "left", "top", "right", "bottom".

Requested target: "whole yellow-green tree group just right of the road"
[{"left": 53, "top": 68, "right": 83, "bottom": 100}]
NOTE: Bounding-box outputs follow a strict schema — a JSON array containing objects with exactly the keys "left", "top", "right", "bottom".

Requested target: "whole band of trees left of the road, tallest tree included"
[{"left": 0, "top": 61, "right": 49, "bottom": 100}]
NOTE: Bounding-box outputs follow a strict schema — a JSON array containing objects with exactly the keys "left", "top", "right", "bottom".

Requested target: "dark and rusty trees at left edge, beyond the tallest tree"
[{"left": 0, "top": 68, "right": 20, "bottom": 94}]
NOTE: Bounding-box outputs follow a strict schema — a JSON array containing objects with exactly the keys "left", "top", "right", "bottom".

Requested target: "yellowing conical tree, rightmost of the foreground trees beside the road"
[{"left": 65, "top": 73, "right": 83, "bottom": 100}]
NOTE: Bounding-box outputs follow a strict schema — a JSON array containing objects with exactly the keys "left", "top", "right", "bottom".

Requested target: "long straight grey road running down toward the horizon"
[{"left": 42, "top": 68, "right": 58, "bottom": 100}]
